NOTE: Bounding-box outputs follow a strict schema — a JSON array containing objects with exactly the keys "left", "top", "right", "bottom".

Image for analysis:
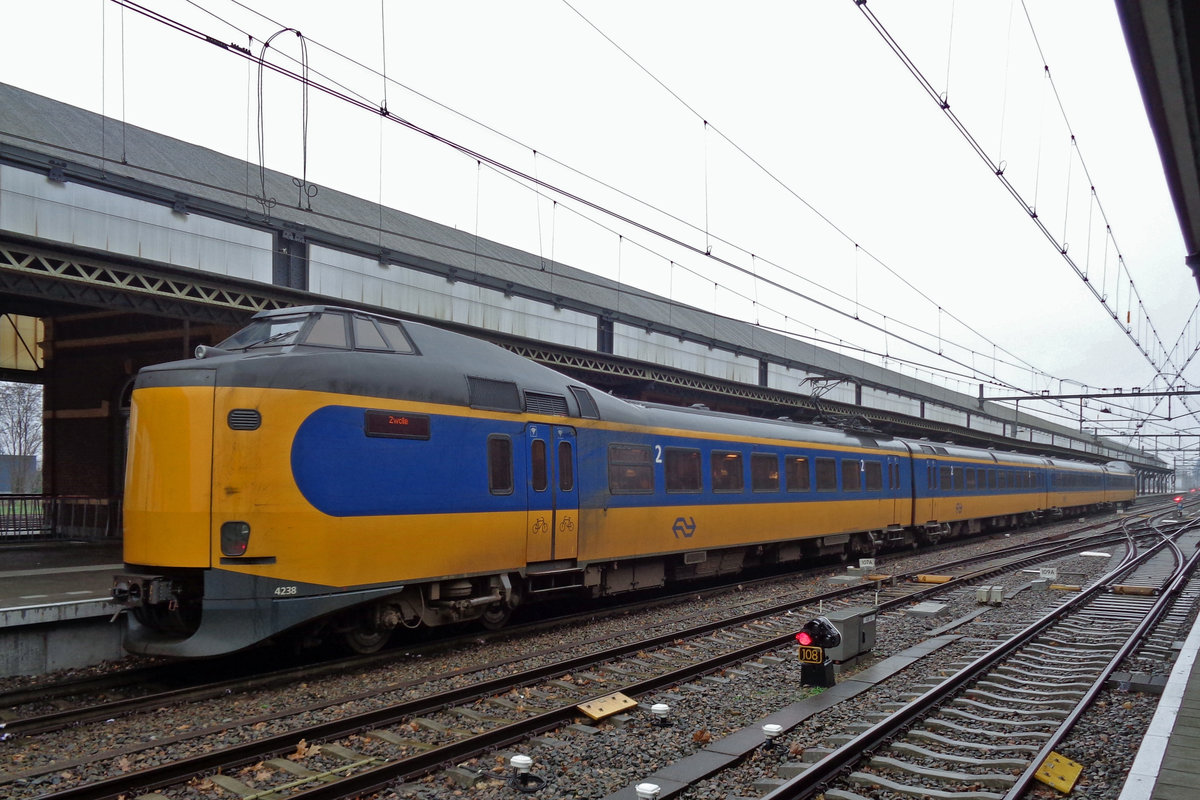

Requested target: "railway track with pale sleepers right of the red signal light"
[{"left": 748, "top": 533, "right": 1200, "bottom": 800}]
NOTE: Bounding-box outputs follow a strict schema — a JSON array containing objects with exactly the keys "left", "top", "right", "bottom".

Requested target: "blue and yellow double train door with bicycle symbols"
[{"left": 526, "top": 423, "right": 580, "bottom": 564}]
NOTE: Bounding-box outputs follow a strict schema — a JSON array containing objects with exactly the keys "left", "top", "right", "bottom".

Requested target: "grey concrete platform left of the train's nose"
[{"left": 0, "top": 540, "right": 125, "bottom": 678}]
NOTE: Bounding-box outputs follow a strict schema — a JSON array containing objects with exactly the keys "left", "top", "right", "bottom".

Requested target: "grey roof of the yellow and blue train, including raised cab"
[{"left": 164, "top": 305, "right": 1128, "bottom": 470}]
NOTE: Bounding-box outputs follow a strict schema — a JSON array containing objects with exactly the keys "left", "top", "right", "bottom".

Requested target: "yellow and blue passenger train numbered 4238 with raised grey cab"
[{"left": 113, "top": 306, "right": 1134, "bottom": 657}]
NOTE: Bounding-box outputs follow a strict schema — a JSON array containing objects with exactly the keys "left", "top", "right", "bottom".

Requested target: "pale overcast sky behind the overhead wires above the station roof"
[{"left": 0, "top": 0, "right": 1200, "bottom": 450}]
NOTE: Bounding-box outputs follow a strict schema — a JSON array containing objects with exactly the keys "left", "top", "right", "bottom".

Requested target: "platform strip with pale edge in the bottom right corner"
[{"left": 1120, "top": 604, "right": 1200, "bottom": 800}]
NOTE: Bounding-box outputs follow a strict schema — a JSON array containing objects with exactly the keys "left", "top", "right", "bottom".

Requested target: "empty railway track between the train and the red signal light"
[{"left": 6, "top": 513, "right": 1171, "bottom": 800}]
